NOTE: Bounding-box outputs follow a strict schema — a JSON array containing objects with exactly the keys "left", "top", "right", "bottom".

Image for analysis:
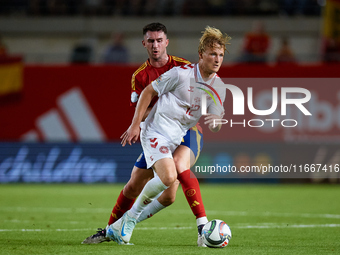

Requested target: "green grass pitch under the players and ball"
[{"left": 0, "top": 184, "right": 340, "bottom": 255}]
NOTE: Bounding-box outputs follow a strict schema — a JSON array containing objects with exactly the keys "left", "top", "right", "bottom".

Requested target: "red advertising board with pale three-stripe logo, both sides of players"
[{"left": 0, "top": 66, "right": 340, "bottom": 142}]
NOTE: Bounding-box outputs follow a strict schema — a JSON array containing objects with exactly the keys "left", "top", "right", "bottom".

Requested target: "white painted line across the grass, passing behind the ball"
[{"left": 0, "top": 223, "right": 340, "bottom": 232}]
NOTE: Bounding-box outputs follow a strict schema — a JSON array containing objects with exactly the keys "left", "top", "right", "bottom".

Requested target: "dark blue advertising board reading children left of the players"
[{"left": 0, "top": 143, "right": 141, "bottom": 183}]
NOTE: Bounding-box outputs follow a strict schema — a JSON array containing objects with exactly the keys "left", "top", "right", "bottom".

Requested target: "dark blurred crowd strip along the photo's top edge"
[{"left": 0, "top": 0, "right": 326, "bottom": 16}]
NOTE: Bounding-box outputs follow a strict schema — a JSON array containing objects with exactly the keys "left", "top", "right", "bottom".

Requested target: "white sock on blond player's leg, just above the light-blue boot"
[{"left": 128, "top": 176, "right": 168, "bottom": 219}]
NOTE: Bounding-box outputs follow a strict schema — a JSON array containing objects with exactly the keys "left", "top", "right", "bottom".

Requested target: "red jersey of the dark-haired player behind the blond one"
[{"left": 130, "top": 55, "right": 190, "bottom": 107}]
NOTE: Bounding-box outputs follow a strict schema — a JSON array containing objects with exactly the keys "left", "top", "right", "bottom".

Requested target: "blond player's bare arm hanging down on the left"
[{"left": 120, "top": 84, "right": 158, "bottom": 146}]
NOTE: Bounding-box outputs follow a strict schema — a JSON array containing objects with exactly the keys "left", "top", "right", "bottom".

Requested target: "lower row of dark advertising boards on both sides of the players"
[{"left": 0, "top": 143, "right": 340, "bottom": 183}]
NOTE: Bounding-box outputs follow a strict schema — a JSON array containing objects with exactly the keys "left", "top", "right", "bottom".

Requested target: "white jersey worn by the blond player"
[{"left": 141, "top": 64, "right": 226, "bottom": 146}]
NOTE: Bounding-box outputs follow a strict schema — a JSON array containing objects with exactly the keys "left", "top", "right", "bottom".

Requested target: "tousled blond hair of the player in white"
[{"left": 198, "top": 26, "right": 231, "bottom": 53}]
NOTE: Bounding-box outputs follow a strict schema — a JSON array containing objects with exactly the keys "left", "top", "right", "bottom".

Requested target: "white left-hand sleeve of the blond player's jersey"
[{"left": 151, "top": 67, "right": 179, "bottom": 96}]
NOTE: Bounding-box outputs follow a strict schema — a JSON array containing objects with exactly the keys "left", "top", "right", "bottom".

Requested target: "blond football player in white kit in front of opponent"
[{"left": 107, "top": 26, "right": 230, "bottom": 244}]
